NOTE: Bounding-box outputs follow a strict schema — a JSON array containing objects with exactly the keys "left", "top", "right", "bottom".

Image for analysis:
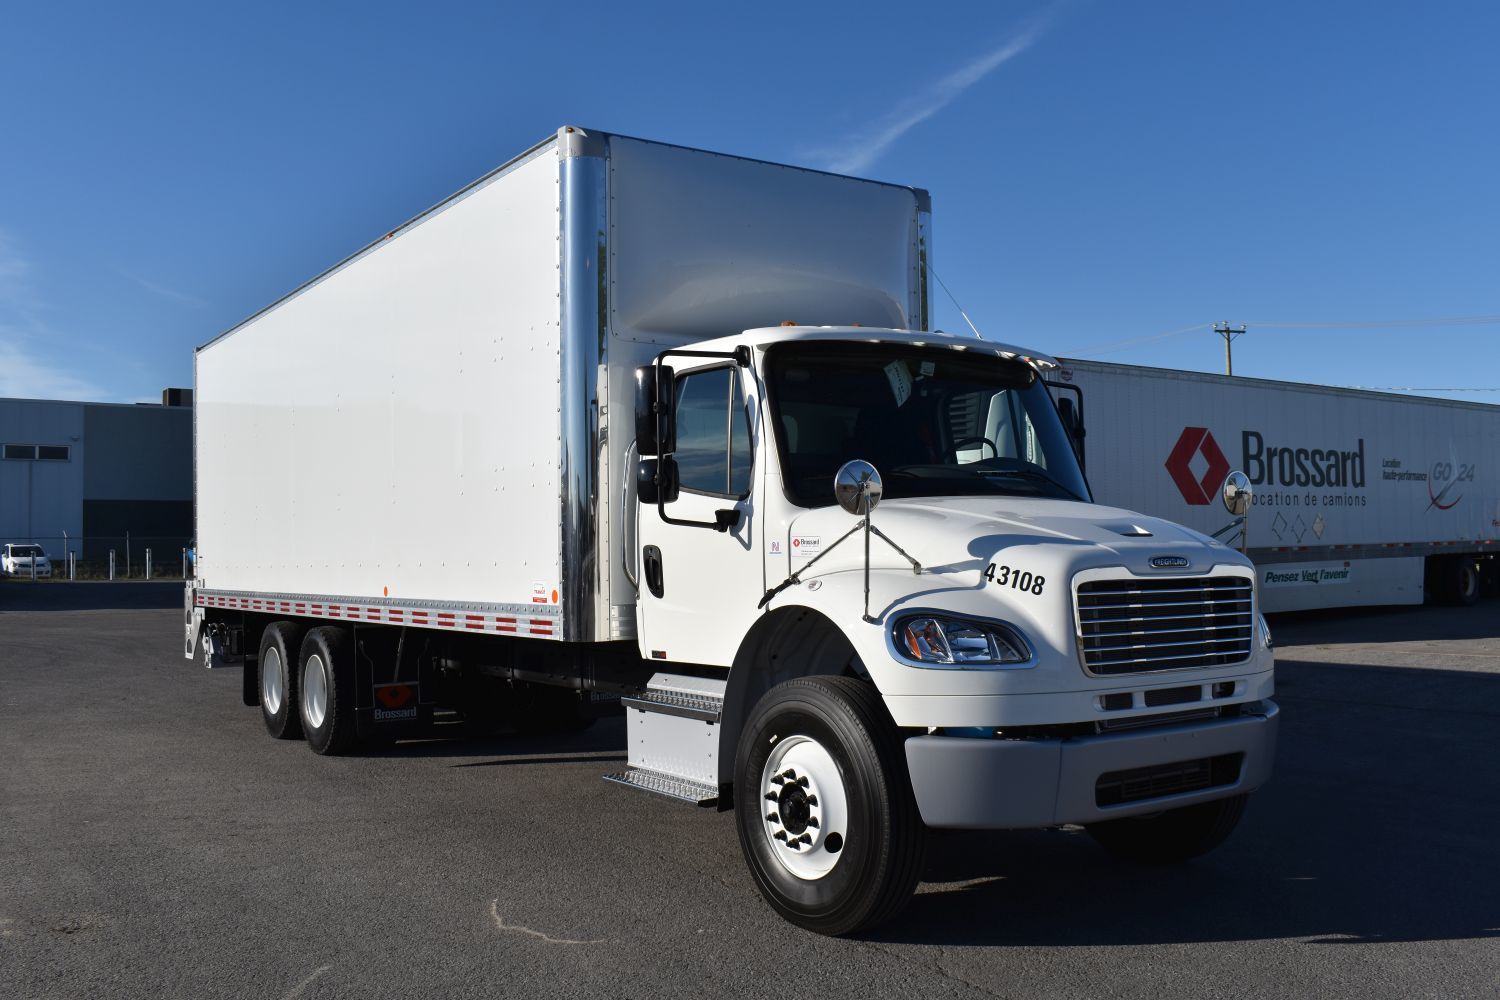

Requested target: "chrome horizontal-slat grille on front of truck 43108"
[{"left": 1079, "top": 576, "right": 1256, "bottom": 675}]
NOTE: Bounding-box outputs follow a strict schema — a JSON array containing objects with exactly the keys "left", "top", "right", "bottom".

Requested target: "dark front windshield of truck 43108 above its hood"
[{"left": 767, "top": 342, "right": 1089, "bottom": 507}]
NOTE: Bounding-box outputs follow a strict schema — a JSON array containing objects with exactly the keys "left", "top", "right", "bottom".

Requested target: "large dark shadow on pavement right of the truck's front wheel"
[{"left": 872, "top": 650, "right": 1500, "bottom": 946}]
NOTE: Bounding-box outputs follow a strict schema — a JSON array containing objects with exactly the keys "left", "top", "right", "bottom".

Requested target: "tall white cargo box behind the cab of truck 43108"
[{"left": 197, "top": 129, "right": 927, "bottom": 640}]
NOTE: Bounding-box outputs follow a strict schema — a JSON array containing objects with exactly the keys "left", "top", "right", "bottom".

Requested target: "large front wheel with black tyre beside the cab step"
[{"left": 735, "top": 676, "right": 927, "bottom": 934}]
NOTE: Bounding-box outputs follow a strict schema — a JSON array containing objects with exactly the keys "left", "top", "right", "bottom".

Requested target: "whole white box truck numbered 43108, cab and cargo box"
[{"left": 186, "top": 127, "right": 1277, "bottom": 934}]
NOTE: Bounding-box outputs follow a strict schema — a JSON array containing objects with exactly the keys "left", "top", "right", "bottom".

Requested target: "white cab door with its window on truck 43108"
[{"left": 636, "top": 363, "right": 765, "bottom": 667}]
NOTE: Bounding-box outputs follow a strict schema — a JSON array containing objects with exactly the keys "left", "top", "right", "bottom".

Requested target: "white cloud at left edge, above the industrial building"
[{"left": 0, "top": 229, "right": 107, "bottom": 399}]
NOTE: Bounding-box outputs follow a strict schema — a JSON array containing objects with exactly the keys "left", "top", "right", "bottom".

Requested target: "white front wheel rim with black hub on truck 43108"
[{"left": 761, "top": 736, "right": 849, "bottom": 882}]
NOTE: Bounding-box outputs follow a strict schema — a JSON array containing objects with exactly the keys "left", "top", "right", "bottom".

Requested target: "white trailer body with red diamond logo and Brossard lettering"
[{"left": 1052, "top": 360, "right": 1500, "bottom": 612}]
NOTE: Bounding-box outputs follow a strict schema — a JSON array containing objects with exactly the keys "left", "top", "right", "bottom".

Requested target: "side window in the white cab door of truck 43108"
[{"left": 675, "top": 367, "right": 752, "bottom": 496}]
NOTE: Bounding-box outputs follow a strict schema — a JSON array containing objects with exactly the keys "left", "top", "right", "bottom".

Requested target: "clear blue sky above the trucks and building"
[{"left": 0, "top": 0, "right": 1500, "bottom": 402}]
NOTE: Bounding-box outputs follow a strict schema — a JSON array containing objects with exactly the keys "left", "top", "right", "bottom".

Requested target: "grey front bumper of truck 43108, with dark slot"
[{"left": 906, "top": 702, "right": 1278, "bottom": 829}]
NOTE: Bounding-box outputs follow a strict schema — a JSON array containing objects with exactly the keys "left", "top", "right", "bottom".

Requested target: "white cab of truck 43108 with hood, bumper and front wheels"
[{"left": 629, "top": 327, "right": 1277, "bottom": 931}]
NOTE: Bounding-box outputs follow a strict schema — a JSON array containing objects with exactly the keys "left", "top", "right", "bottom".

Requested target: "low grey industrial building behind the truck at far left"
[{"left": 0, "top": 388, "right": 194, "bottom": 571}]
